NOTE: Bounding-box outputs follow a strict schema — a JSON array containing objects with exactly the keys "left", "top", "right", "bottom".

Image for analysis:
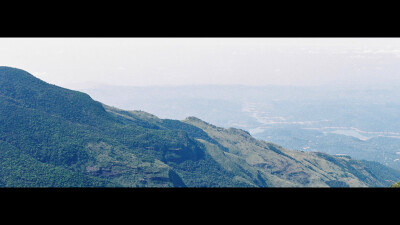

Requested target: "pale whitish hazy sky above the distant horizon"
[{"left": 0, "top": 38, "right": 400, "bottom": 88}]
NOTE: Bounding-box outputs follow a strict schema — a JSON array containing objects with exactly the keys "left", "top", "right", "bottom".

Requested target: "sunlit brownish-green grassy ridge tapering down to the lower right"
[{"left": 184, "top": 117, "right": 399, "bottom": 187}]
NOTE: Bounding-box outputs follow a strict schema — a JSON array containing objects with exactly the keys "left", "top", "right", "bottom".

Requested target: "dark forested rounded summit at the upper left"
[{"left": 0, "top": 66, "right": 111, "bottom": 124}]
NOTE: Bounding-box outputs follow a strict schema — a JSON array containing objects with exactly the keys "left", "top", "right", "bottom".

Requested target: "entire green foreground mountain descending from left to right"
[{"left": 0, "top": 67, "right": 400, "bottom": 187}]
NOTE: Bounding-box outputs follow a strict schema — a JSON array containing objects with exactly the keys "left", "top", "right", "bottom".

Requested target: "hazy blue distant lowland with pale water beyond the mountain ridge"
[{"left": 80, "top": 85, "right": 400, "bottom": 170}]
